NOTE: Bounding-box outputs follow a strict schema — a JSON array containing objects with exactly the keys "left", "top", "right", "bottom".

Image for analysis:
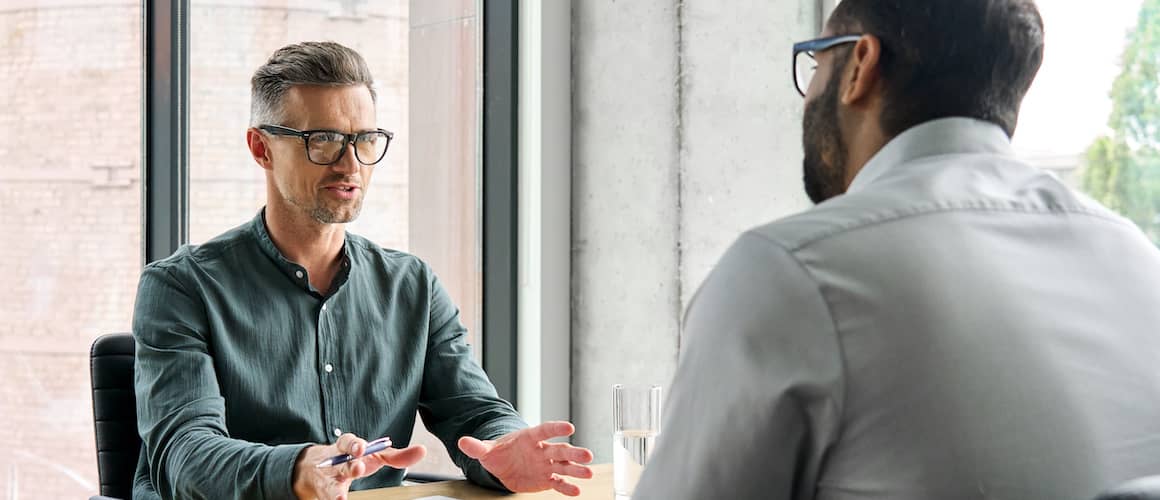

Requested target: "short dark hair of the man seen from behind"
[{"left": 829, "top": 0, "right": 1043, "bottom": 137}]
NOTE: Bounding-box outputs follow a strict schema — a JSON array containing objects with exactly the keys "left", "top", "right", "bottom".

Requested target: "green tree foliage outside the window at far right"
[{"left": 1082, "top": 0, "right": 1160, "bottom": 244}]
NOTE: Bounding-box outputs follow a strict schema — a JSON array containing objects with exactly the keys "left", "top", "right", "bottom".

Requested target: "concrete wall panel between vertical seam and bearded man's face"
[{"left": 680, "top": 0, "right": 817, "bottom": 305}]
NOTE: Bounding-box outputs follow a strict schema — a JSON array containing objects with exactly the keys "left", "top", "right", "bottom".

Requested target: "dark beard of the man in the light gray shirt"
[{"left": 802, "top": 72, "right": 847, "bottom": 204}]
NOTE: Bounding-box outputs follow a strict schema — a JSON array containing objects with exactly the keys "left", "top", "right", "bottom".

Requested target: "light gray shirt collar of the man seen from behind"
[{"left": 847, "top": 117, "right": 1015, "bottom": 193}]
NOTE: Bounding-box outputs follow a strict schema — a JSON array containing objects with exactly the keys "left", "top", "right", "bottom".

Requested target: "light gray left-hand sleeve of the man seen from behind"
[{"left": 633, "top": 233, "right": 843, "bottom": 500}]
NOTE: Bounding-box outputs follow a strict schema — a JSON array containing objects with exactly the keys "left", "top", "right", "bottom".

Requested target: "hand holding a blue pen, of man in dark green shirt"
[{"left": 293, "top": 434, "right": 427, "bottom": 500}]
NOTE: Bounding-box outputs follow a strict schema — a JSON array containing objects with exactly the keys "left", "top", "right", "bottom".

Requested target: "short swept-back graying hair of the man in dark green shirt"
[{"left": 249, "top": 42, "right": 376, "bottom": 126}]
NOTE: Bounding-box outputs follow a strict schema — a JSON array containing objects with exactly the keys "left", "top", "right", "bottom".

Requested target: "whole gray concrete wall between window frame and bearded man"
[{"left": 572, "top": 0, "right": 828, "bottom": 462}]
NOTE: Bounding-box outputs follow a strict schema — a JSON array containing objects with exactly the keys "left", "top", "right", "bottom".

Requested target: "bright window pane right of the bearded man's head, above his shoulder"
[{"left": 1014, "top": 0, "right": 1160, "bottom": 244}]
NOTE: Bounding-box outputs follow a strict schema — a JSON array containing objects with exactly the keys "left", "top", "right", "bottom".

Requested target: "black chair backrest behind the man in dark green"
[{"left": 89, "top": 333, "right": 142, "bottom": 499}]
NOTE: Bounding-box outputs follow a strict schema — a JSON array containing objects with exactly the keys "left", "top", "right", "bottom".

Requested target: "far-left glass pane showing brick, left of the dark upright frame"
[{"left": 0, "top": 0, "right": 142, "bottom": 499}]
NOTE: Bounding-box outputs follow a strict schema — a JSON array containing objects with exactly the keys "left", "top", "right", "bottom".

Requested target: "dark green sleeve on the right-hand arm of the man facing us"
[{"left": 419, "top": 267, "right": 528, "bottom": 490}]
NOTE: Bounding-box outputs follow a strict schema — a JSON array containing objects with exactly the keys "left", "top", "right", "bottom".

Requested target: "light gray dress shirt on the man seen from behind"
[{"left": 635, "top": 118, "right": 1160, "bottom": 500}]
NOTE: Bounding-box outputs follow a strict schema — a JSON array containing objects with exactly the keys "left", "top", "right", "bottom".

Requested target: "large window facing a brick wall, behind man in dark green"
[{"left": 0, "top": 0, "right": 498, "bottom": 499}]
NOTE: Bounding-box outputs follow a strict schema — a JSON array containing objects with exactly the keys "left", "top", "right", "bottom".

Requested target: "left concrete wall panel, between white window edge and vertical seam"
[{"left": 572, "top": 0, "right": 681, "bottom": 462}]
